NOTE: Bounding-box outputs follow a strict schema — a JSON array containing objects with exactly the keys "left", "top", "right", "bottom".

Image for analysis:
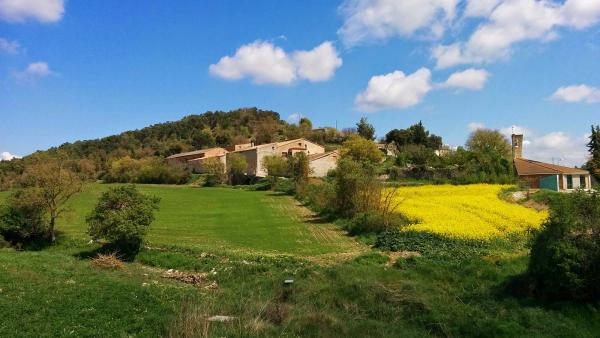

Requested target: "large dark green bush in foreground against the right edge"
[{"left": 528, "top": 192, "right": 600, "bottom": 301}]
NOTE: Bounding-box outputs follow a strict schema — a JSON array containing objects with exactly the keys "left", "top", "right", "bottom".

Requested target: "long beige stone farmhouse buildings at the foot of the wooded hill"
[{"left": 167, "top": 138, "right": 339, "bottom": 177}]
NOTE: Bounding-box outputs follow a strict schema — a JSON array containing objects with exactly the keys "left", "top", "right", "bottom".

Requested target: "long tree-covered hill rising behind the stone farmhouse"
[{"left": 0, "top": 108, "right": 343, "bottom": 189}]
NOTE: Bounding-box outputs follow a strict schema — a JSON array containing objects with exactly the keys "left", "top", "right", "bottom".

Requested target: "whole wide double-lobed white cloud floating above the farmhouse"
[{"left": 209, "top": 41, "right": 342, "bottom": 85}]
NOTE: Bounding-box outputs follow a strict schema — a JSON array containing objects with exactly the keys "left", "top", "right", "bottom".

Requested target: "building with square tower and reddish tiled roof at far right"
[{"left": 512, "top": 134, "right": 592, "bottom": 192}]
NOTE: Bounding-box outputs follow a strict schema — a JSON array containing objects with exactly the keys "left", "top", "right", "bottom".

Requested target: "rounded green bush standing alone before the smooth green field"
[{"left": 87, "top": 185, "right": 160, "bottom": 258}]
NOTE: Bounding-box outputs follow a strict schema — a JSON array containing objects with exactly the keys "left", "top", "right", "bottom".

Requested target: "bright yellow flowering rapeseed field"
[{"left": 395, "top": 184, "right": 548, "bottom": 240}]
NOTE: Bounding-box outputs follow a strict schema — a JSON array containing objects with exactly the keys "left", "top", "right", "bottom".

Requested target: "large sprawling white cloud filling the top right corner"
[{"left": 432, "top": 0, "right": 600, "bottom": 68}]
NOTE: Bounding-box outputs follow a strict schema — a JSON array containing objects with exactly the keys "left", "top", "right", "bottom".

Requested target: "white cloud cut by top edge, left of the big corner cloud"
[{"left": 338, "top": 0, "right": 458, "bottom": 46}]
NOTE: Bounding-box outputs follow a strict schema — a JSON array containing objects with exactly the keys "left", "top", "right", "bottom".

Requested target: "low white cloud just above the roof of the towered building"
[{"left": 500, "top": 126, "right": 589, "bottom": 166}]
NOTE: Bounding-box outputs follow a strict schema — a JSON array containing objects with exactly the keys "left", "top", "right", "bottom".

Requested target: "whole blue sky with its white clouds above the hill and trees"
[{"left": 0, "top": 0, "right": 600, "bottom": 165}]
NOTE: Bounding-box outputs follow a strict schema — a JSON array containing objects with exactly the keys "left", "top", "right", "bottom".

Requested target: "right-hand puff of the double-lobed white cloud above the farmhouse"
[{"left": 292, "top": 41, "right": 342, "bottom": 82}]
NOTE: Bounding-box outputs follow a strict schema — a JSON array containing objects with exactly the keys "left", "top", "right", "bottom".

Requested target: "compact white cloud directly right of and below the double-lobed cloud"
[{"left": 355, "top": 68, "right": 432, "bottom": 111}]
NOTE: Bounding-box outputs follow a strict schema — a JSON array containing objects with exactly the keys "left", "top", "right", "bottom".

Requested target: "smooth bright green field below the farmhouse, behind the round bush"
[{"left": 52, "top": 184, "right": 358, "bottom": 256}]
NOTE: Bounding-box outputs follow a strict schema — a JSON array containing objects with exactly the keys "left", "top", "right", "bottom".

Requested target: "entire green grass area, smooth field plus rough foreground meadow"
[{"left": 0, "top": 185, "right": 600, "bottom": 337}]
